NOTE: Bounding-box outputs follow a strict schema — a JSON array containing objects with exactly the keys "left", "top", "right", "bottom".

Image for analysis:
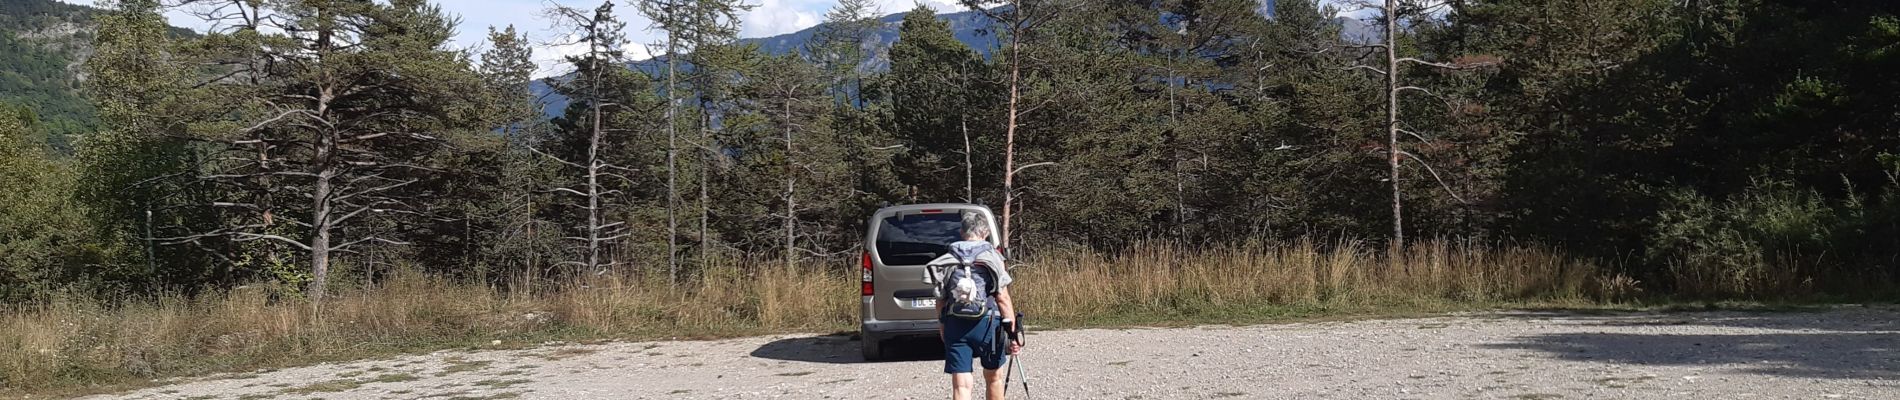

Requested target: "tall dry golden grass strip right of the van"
[{"left": 1013, "top": 241, "right": 1634, "bottom": 326}]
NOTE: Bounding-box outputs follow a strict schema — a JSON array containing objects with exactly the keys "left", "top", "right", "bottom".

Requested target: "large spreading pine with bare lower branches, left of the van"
[{"left": 131, "top": 0, "right": 483, "bottom": 301}]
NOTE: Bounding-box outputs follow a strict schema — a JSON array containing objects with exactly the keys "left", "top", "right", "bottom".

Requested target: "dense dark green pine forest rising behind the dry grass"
[{"left": 0, "top": 0, "right": 1900, "bottom": 301}]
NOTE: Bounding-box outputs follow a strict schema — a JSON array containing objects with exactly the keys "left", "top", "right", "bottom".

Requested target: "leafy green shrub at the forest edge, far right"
[{"left": 1647, "top": 166, "right": 1900, "bottom": 300}]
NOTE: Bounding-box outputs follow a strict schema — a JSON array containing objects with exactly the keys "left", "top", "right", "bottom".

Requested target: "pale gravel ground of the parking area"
[{"left": 99, "top": 305, "right": 1900, "bottom": 400}]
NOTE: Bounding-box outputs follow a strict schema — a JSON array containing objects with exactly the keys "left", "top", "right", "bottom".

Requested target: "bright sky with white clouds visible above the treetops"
[{"left": 61, "top": 0, "right": 1368, "bottom": 76}]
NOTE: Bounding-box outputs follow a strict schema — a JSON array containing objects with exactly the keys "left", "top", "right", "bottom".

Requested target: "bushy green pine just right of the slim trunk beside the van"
[{"left": 1003, "top": 2, "right": 1178, "bottom": 248}]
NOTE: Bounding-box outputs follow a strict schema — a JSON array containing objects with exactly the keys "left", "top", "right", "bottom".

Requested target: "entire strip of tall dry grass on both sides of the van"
[{"left": 0, "top": 241, "right": 1630, "bottom": 394}]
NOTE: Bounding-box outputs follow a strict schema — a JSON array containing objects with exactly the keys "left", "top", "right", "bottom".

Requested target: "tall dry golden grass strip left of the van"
[{"left": 0, "top": 255, "right": 857, "bottom": 396}]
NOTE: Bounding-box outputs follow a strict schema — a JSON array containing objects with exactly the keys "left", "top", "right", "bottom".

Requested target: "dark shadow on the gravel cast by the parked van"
[{"left": 752, "top": 336, "right": 944, "bottom": 364}]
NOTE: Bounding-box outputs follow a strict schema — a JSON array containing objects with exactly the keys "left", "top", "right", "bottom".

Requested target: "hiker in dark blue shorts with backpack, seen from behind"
[{"left": 931, "top": 212, "right": 1022, "bottom": 400}]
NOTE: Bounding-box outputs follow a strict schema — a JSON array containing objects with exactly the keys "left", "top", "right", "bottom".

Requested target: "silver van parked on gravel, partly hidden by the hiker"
[{"left": 859, "top": 205, "right": 1001, "bottom": 360}]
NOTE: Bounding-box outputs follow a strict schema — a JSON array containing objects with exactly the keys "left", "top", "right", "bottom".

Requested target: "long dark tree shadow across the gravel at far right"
[{"left": 1482, "top": 311, "right": 1900, "bottom": 379}]
